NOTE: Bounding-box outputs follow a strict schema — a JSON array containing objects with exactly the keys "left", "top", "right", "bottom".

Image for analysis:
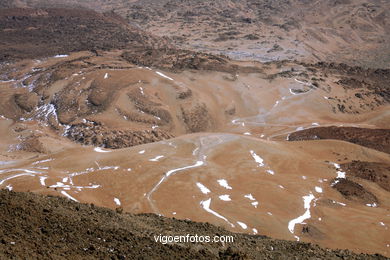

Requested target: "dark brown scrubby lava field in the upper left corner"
[{"left": 0, "top": 8, "right": 166, "bottom": 62}]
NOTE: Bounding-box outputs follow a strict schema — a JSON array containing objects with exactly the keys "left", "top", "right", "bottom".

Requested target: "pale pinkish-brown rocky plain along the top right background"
[{"left": 3, "top": 0, "right": 390, "bottom": 68}]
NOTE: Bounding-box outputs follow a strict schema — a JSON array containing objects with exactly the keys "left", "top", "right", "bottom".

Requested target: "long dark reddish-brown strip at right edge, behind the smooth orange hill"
[{"left": 288, "top": 126, "right": 390, "bottom": 153}]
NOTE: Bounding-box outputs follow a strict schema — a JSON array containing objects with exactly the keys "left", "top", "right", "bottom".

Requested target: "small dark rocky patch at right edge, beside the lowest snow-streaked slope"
[{"left": 341, "top": 161, "right": 390, "bottom": 191}]
